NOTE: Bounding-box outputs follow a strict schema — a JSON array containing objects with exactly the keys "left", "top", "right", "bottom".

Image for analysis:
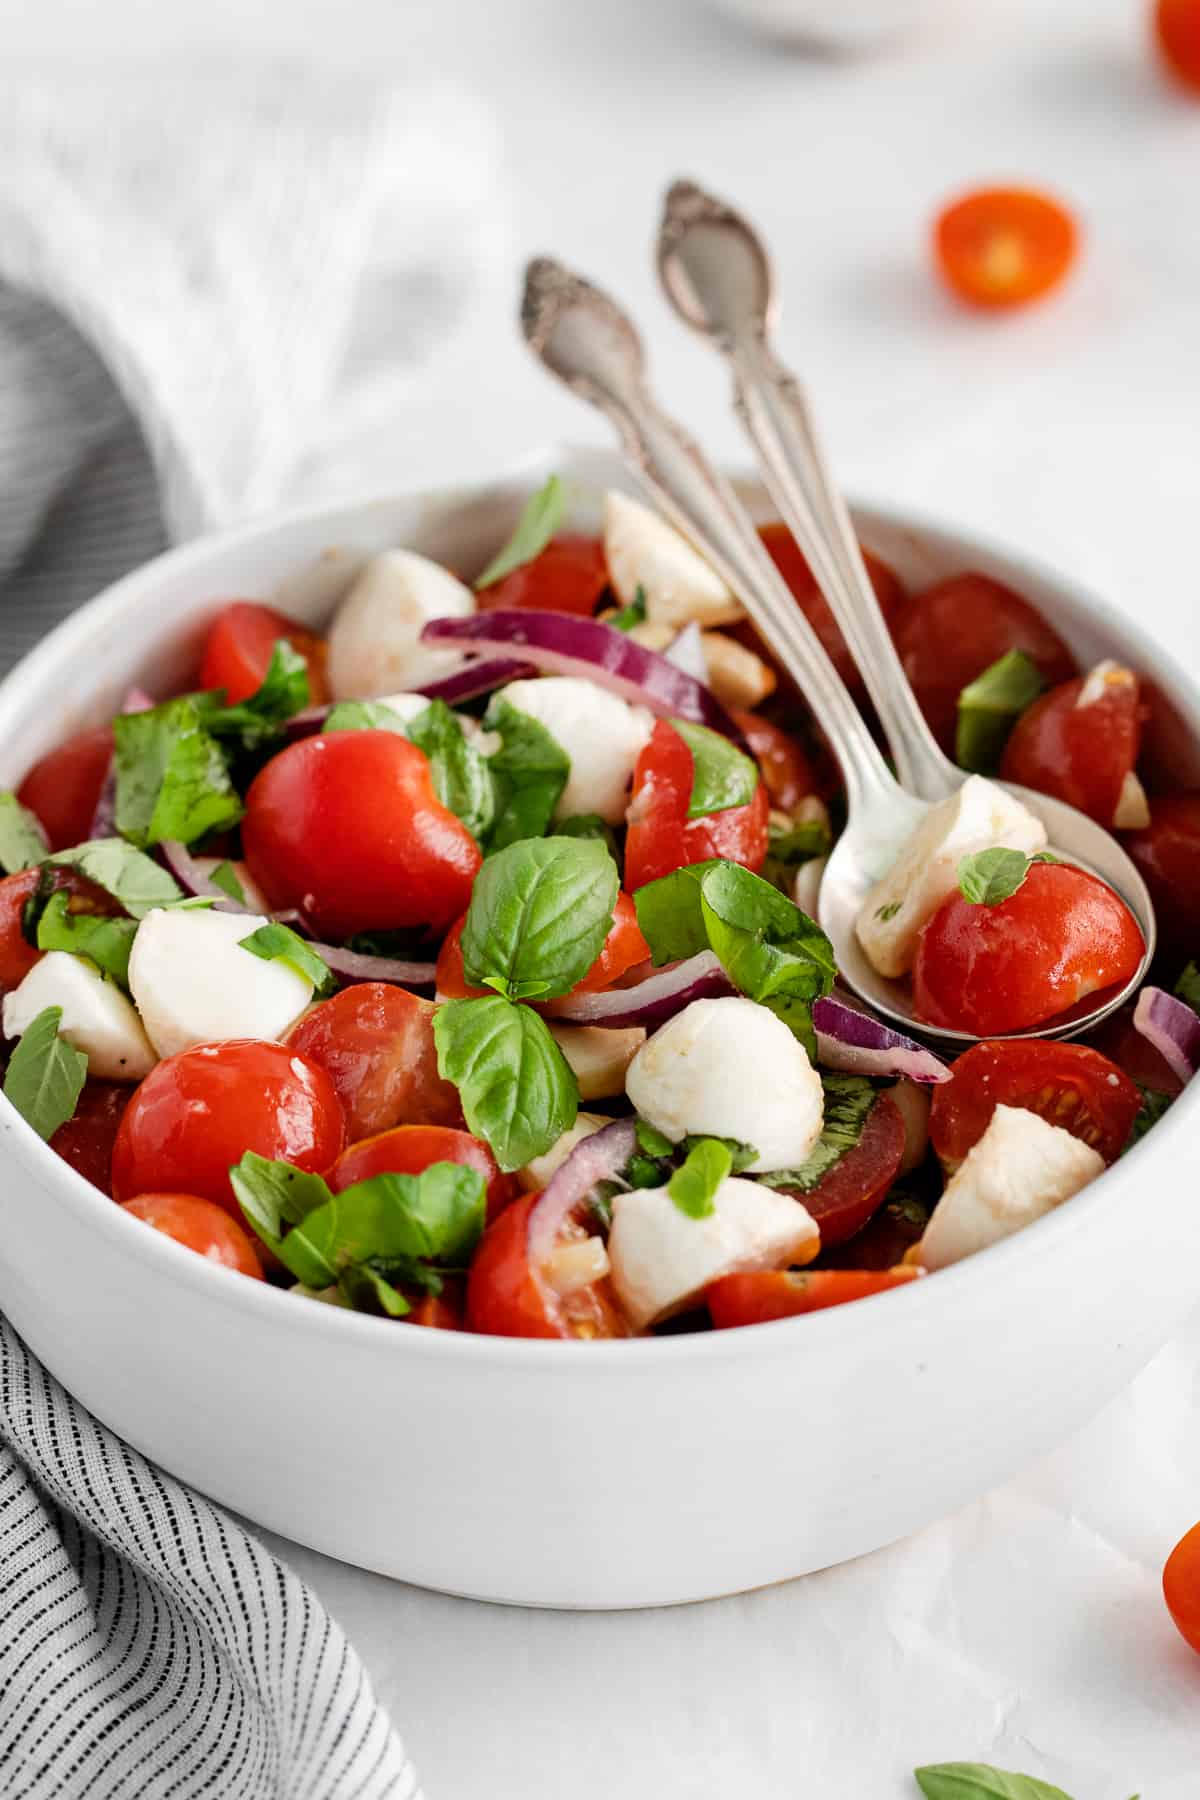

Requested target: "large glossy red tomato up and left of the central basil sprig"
[{"left": 241, "top": 731, "right": 482, "bottom": 938}]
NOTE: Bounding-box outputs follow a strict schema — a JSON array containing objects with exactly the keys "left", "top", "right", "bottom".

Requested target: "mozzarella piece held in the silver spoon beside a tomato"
[{"left": 855, "top": 776, "right": 1045, "bottom": 977}]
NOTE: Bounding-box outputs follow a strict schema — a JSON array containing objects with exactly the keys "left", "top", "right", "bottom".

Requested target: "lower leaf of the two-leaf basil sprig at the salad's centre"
[{"left": 434, "top": 994, "right": 579, "bottom": 1174}]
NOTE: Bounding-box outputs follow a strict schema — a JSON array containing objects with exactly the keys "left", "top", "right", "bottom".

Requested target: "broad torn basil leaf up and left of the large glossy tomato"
[{"left": 113, "top": 698, "right": 243, "bottom": 850}]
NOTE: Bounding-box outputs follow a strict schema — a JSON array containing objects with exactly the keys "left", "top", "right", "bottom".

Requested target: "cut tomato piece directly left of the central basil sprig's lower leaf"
[{"left": 288, "top": 981, "right": 462, "bottom": 1143}]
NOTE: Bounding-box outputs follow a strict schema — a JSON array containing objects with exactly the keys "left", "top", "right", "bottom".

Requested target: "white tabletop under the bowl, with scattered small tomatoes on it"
[{"left": 0, "top": 0, "right": 1200, "bottom": 1800}]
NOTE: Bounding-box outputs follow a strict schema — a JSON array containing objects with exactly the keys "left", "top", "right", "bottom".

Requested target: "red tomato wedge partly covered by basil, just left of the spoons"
[{"left": 624, "top": 718, "right": 770, "bottom": 891}]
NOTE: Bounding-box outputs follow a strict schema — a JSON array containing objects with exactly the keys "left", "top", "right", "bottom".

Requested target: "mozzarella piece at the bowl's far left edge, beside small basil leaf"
[{"left": 4, "top": 950, "right": 158, "bottom": 1082}]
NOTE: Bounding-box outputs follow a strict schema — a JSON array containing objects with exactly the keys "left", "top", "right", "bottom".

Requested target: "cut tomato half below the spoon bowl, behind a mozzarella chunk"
[{"left": 928, "top": 1037, "right": 1141, "bottom": 1175}]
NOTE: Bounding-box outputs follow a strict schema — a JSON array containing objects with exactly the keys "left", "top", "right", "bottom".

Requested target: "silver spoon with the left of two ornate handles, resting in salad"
[{"left": 522, "top": 257, "right": 1153, "bottom": 1046}]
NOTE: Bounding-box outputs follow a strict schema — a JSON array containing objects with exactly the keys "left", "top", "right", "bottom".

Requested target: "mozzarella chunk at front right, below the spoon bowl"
[{"left": 910, "top": 1105, "right": 1105, "bottom": 1269}]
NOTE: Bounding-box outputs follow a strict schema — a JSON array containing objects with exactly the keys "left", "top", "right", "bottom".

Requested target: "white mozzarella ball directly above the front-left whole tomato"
[{"left": 130, "top": 907, "right": 313, "bottom": 1057}]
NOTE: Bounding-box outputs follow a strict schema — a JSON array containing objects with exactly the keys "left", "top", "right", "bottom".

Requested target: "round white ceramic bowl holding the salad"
[{"left": 0, "top": 454, "right": 1200, "bottom": 1607}]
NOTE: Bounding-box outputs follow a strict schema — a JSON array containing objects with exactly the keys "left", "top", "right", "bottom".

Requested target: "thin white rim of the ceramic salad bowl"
[{"left": 0, "top": 460, "right": 1200, "bottom": 1375}]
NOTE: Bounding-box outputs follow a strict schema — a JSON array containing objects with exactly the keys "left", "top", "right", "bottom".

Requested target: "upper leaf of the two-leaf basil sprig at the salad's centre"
[{"left": 462, "top": 837, "right": 619, "bottom": 1001}]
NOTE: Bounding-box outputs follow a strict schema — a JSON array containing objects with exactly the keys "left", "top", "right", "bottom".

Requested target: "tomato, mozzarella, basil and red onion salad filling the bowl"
[{"left": 0, "top": 479, "right": 1200, "bottom": 1339}]
